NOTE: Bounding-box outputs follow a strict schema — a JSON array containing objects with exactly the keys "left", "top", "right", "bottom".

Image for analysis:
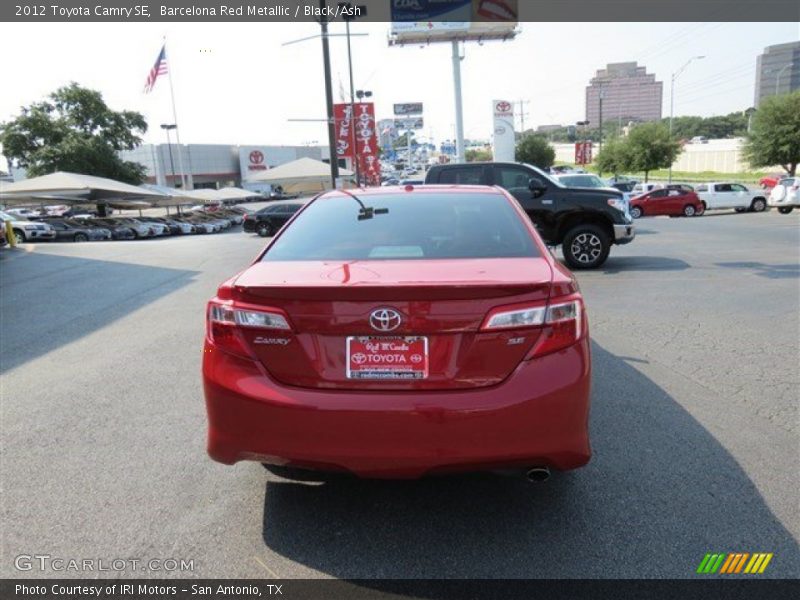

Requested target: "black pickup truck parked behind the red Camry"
[{"left": 425, "top": 162, "right": 636, "bottom": 269}]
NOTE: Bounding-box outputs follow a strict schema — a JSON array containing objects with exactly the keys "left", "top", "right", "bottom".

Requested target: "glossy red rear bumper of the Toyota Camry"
[{"left": 203, "top": 339, "right": 591, "bottom": 478}]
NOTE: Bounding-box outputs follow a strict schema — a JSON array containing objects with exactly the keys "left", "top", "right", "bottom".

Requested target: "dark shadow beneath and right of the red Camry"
[{"left": 263, "top": 344, "right": 800, "bottom": 580}]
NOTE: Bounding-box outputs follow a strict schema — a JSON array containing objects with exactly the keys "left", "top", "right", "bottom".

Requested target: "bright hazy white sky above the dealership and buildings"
[{"left": 0, "top": 22, "right": 800, "bottom": 168}]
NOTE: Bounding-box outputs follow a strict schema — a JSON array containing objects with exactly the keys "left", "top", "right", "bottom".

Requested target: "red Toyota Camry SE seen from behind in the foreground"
[{"left": 203, "top": 185, "right": 591, "bottom": 479}]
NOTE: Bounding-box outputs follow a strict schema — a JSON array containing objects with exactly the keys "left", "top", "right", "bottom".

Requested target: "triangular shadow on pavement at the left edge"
[{"left": 0, "top": 252, "right": 197, "bottom": 373}]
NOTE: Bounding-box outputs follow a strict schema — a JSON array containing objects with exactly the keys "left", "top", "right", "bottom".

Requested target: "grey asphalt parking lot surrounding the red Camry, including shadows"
[{"left": 0, "top": 211, "right": 800, "bottom": 578}]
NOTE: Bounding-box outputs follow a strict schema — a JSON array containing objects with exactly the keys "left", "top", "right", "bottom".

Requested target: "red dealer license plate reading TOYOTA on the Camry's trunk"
[{"left": 347, "top": 336, "right": 428, "bottom": 379}]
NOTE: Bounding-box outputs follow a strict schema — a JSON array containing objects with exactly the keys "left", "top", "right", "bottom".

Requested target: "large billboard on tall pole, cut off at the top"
[{"left": 390, "top": 0, "right": 519, "bottom": 44}]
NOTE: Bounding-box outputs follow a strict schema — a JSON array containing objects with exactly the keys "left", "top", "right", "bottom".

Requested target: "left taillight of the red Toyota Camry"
[{"left": 207, "top": 300, "right": 291, "bottom": 358}]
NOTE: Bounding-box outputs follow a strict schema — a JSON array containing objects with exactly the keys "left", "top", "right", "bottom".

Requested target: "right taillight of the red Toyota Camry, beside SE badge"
[{"left": 481, "top": 296, "right": 586, "bottom": 359}]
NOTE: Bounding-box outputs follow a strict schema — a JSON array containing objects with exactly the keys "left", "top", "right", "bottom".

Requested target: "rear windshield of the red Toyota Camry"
[{"left": 263, "top": 192, "right": 539, "bottom": 261}]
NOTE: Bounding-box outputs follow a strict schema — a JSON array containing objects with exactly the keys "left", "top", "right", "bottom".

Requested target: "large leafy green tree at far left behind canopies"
[{"left": 0, "top": 83, "right": 147, "bottom": 185}]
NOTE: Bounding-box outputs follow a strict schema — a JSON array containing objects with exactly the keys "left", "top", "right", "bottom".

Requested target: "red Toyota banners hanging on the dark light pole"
[{"left": 333, "top": 102, "right": 381, "bottom": 185}]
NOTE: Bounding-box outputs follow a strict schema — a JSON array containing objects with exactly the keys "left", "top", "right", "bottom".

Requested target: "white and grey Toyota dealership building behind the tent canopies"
[{"left": 121, "top": 144, "right": 332, "bottom": 191}]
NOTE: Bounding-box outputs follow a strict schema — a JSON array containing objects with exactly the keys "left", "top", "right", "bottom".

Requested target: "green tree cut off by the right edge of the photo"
[{"left": 744, "top": 91, "right": 800, "bottom": 177}]
